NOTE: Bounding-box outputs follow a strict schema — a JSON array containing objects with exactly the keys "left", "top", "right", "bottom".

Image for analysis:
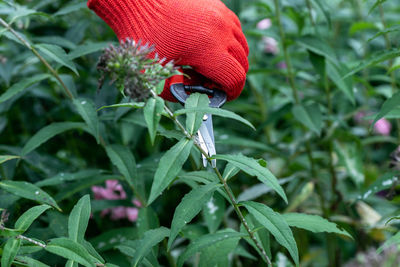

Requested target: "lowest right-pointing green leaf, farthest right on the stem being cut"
[{"left": 282, "top": 213, "right": 353, "bottom": 239}]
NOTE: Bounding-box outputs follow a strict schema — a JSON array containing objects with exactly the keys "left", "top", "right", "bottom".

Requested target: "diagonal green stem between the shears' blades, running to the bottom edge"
[{"left": 150, "top": 90, "right": 272, "bottom": 266}]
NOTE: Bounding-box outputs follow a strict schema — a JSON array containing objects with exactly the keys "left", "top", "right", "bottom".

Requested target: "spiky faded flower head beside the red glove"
[{"left": 97, "top": 39, "right": 177, "bottom": 101}]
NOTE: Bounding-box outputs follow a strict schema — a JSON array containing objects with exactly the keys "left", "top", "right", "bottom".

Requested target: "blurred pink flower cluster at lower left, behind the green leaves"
[{"left": 92, "top": 180, "right": 142, "bottom": 222}]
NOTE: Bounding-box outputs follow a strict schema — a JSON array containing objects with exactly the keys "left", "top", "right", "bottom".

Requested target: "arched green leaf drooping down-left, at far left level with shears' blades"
[{"left": 21, "top": 122, "right": 86, "bottom": 156}]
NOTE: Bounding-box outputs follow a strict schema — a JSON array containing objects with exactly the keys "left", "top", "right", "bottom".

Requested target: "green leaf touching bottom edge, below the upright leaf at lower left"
[{"left": 45, "top": 237, "right": 96, "bottom": 267}]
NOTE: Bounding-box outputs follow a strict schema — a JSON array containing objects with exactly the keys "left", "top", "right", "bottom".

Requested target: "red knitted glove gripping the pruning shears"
[{"left": 88, "top": 0, "right": 249, "bottom": 100}]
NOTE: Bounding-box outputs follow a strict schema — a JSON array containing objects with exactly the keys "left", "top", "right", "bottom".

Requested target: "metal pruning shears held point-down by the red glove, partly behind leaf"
[{"left": 170, "top": 78, "right": 227, "bottom": 168}]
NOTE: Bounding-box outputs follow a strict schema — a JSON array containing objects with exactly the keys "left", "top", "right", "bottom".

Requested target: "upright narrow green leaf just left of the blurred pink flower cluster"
[{"left": 68, "top": 195, "right": 90, "bottom": 245}]
